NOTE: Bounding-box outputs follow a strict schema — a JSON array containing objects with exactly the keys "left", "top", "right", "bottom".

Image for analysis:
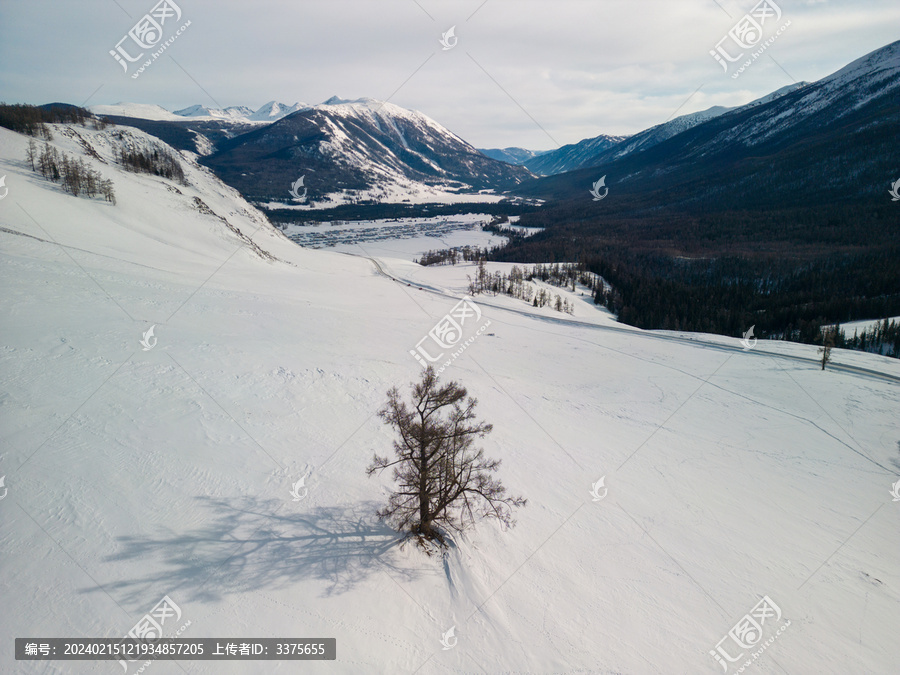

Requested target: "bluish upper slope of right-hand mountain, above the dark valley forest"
[{"left": 523, "top": 41, "right": 900, "bottom": 210}]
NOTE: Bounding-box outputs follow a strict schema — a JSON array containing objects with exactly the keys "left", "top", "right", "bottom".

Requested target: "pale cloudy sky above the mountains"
[{"left": 0, "top": 0, "right": 900, "bottom": 150}]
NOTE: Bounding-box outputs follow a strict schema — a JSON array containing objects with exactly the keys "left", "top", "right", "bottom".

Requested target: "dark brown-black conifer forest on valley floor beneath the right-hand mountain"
[{"left": 488, "top": 205, "right": 900, "bottom": 355}]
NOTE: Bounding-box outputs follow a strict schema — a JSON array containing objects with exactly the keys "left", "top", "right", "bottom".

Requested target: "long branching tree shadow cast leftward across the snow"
[{"left": 85, "top": 497, "right": 415, "bottom": 609}]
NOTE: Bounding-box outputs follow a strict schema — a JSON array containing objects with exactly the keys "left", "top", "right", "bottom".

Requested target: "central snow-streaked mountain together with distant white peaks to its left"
[{"left": 92, "top": 96, "right": 534, "bottom": 208}]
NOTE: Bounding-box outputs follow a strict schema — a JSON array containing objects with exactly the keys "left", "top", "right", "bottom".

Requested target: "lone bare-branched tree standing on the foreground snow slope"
[{"left": 366, "top": 367, "right": 527, "bottom": 546}]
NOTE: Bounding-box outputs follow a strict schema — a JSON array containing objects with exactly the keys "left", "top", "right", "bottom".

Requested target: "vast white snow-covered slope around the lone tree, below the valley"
[{"left": 0, "top": 127, "right": 900, "bottom": 675}]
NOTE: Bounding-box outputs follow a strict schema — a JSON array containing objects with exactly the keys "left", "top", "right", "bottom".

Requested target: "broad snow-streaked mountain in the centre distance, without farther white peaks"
[{"left": 204, "top": 96, "right": 533, "bottom": 202}]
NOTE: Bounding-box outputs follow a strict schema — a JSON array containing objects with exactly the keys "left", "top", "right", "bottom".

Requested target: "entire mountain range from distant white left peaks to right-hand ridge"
[{"left": 92, "top": 43, "right": 900, "bottom": 219}]
